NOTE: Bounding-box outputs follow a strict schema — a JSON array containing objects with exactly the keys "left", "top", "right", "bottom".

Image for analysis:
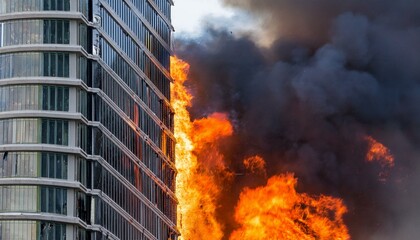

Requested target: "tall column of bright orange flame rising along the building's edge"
[{"left": 171, "top": 57, "right": 233, "bottom": 240}]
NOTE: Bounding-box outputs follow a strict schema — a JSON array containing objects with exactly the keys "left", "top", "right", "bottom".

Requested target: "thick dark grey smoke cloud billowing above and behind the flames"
[{"left": 176, "top": 0, "right": 420, "bottom": 240}]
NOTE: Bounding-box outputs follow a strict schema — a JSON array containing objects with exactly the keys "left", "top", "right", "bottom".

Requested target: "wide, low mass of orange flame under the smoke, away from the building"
[{"left": 230, "top": 174, "right": 350, "bottom": 240}]
